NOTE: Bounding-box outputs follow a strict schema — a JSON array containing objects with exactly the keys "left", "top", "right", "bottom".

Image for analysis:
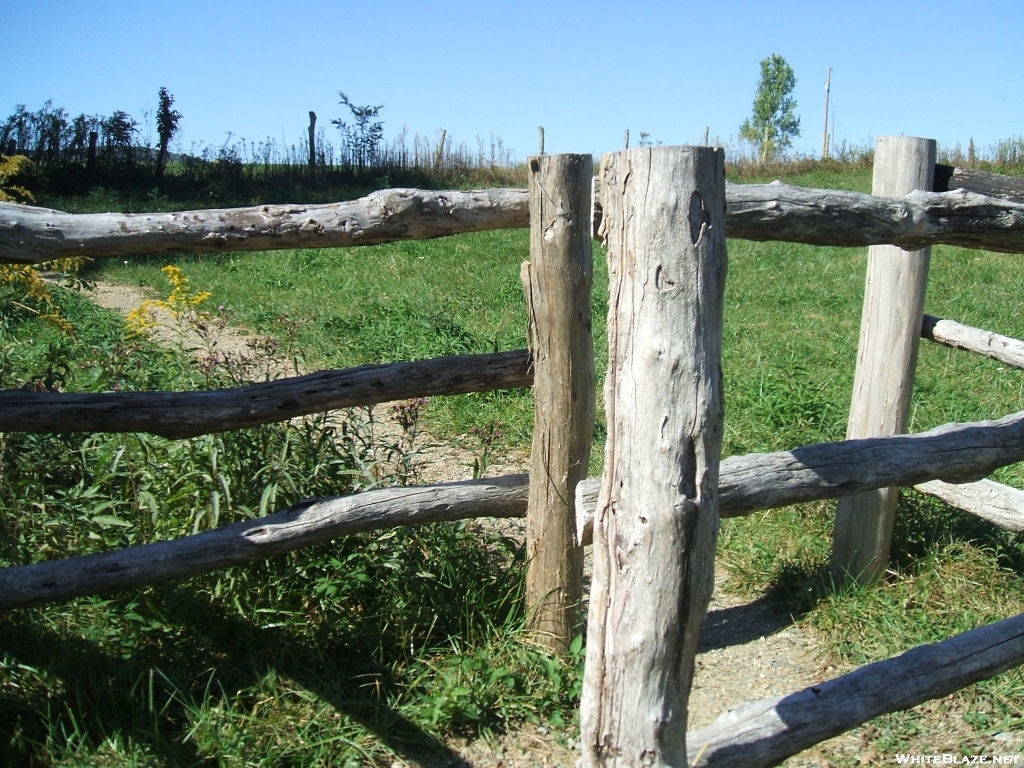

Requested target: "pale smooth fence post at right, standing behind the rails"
[{"left": 831, "top": 136, "right": 935, "bottom": 584}]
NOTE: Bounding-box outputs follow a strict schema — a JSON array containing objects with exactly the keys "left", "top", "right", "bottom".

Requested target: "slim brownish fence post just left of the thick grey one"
[{"left": 522, "top": 155, "right": 597, "bottom": 652}]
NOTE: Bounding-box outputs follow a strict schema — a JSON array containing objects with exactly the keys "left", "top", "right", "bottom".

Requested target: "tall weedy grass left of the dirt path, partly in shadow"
[{"left": 0, "top": 294, "right": 582, "bottom": 766}]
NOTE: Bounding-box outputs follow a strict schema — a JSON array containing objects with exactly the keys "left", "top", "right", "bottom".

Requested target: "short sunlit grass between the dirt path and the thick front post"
[{"left": 88, "top": 229, "right": 607, "bottom": 456}]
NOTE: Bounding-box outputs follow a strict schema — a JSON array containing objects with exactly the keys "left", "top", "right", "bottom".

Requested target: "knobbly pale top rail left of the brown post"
[{"left": 0, "top": 189, "right": 529, "bottom": 263}]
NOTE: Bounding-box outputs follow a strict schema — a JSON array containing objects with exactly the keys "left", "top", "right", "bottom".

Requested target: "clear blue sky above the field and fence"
[{"left": 0, "top": 0, "right": 1024, "bottom": 160}]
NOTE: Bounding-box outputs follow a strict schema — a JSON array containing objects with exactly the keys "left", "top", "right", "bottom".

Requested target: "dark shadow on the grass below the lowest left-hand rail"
[{"left": 0, "top": 588, "right": 462, "bottom": 766}]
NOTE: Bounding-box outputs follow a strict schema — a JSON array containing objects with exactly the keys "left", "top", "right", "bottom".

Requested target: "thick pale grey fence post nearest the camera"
[{"left": 581, "top": 146, "right": 726, "bottom": 766}]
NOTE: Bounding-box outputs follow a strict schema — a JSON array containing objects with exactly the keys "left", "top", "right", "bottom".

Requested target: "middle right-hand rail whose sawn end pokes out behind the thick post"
[{"left": 577, "top": 412, "right": 1024, "bottom": 544}]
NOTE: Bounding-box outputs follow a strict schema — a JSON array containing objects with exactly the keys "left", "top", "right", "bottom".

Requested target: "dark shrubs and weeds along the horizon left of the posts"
[{"left": 0, "top": 88, "right": 521, "bottom": 204}]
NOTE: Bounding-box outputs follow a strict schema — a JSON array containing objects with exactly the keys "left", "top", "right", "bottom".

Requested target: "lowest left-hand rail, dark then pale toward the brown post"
[{"left": 0, "top": 475, "right": 528, "bottom": 608}]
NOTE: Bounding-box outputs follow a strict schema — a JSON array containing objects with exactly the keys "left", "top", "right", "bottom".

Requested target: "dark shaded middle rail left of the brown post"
[{"left": 0, "top": 349, "right": 534, "bottom": 438}]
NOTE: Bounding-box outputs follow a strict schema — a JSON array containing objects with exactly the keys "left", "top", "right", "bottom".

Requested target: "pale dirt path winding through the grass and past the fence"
[{"left": 79, "top": 283, "right": 831, "bottom": 768}]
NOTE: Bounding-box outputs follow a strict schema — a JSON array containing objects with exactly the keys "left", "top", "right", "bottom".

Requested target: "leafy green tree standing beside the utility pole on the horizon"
[{"left": 739, "top": 53, "right": 800, "bottom": 163}]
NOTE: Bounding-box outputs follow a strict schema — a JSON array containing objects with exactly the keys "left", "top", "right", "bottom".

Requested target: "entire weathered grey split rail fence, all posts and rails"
[{"left": 0, "top": 137, "right": 1024, "bottom": 766}]
